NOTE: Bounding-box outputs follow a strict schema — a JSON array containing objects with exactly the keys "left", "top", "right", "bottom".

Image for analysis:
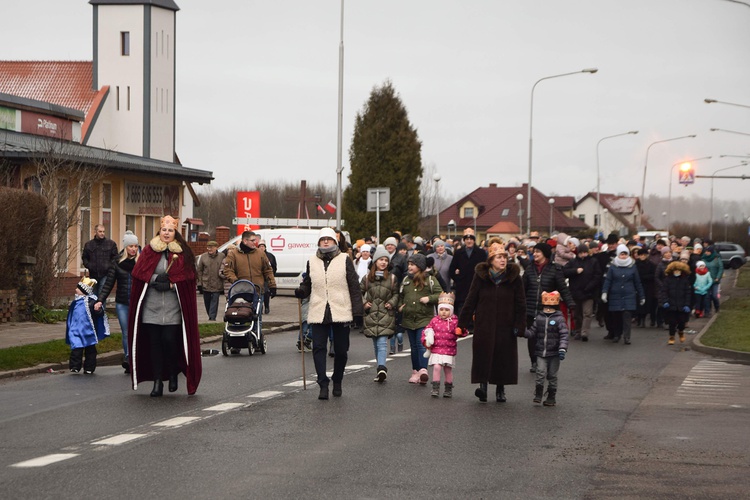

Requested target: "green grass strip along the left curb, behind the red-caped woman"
[{"left": 0, "top": 323, "right": 235, "bottom": 371}]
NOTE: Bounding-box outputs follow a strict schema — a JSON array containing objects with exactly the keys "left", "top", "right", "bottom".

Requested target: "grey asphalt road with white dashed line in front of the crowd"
[{"left": 0, "top": 318, "right": 750, "bottom": 499}]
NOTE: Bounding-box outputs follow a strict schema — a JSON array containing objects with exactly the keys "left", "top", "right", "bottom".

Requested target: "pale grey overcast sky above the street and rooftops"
[{"left": 0, "top": 0, "right": 750, "bottom": 209}]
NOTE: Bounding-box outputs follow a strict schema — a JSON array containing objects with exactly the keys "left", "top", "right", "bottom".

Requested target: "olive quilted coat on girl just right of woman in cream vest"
[{"left": 360, "top": 273, "right": 399, "bottom": 337}]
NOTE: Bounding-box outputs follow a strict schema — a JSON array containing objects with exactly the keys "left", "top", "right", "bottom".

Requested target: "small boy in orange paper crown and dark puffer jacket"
[{"left": 525, "top": 291, "right": 568, "bottom": 406}]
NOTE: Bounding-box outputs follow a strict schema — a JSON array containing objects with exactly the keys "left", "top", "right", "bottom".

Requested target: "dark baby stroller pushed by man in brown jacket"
[{"left": 221, "top": 280, "right": 267, "bottom": 356}]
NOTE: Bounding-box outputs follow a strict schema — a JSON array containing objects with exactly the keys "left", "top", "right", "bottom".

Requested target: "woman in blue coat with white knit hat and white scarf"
[{"left": 601, "top": 244, "right": 646, "bottom": 344}]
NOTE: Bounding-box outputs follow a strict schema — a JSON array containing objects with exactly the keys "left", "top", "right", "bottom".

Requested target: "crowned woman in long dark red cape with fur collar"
[{"left": 128, "top": 215, "right": 202, "bottom": 397}]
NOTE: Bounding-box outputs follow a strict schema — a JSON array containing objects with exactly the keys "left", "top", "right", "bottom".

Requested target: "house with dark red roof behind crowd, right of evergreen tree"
[{"left": 440, "top": 183, "right": 589, "bottom": 240}]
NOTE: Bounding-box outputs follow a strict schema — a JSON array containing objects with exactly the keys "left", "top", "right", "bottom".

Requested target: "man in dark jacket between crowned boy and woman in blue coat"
[{"left": 563, "top": 243, "right": 602, "bottom": 342}]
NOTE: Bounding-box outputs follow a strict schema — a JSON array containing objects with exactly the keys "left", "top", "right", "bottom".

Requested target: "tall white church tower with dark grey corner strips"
[{"left": 83, "top": 0, "right": 179, "bottom": 162}]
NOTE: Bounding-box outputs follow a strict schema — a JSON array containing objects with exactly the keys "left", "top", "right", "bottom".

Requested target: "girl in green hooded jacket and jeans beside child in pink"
[{"left": 398, "top": 248, "right": 443, "bottom": 385}]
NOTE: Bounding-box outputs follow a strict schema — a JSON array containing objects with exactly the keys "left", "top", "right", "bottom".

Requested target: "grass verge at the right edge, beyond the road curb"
[{"left": 701, "top": 266, "right": 750, "bottom": 352}]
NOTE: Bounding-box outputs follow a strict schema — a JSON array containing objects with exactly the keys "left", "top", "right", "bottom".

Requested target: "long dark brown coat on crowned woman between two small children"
[{"left": 458, "top": 262, "right": 526, "bottom": 385}]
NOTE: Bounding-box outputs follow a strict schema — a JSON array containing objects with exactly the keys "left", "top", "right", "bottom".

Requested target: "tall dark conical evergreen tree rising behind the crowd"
[{"left": 342, "top": 81, "right": 422, "bottom": 240}]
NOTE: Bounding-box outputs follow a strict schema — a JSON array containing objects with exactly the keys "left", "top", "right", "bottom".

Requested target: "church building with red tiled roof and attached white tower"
[{"left": 0, "top": 0, "right": 213, "bottom": 300}]
